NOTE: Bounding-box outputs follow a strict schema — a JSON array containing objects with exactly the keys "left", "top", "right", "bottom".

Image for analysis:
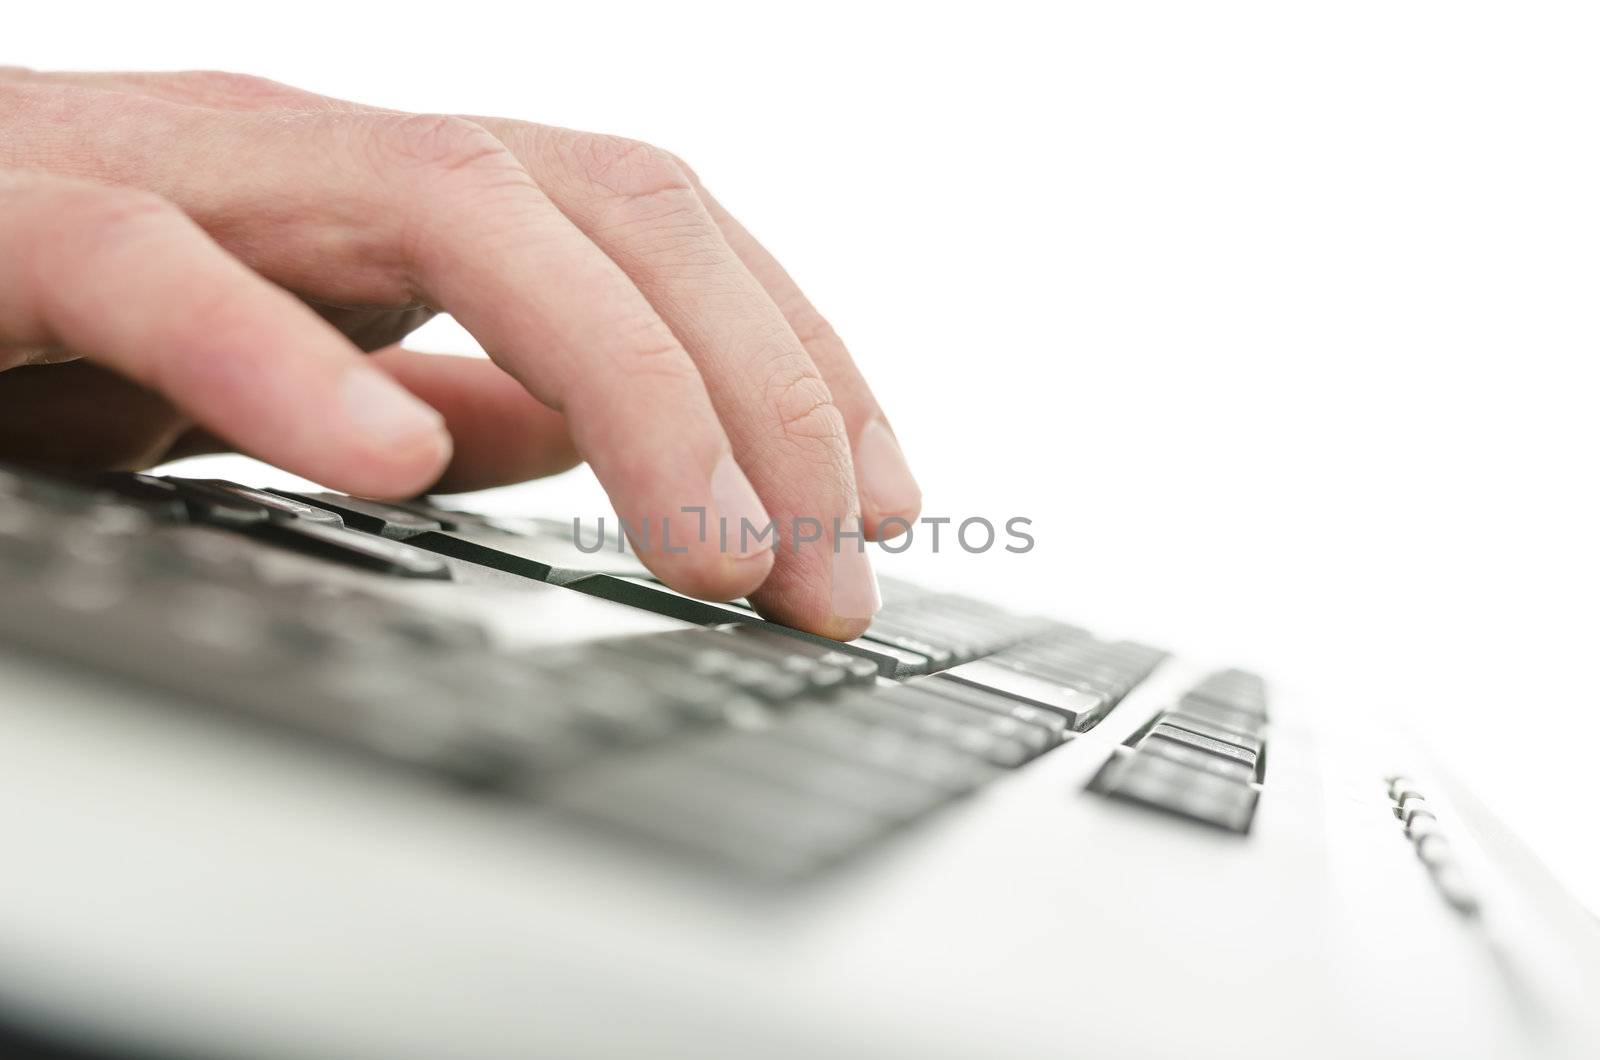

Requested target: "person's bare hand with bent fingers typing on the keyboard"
[{"left": 0, "top": 67, "right": 922, "bottom": 639}]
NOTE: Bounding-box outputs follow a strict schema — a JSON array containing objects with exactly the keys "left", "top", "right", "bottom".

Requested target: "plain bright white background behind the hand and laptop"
[{"left": 15, "top": 0, "right": 1600, "bottom": 908}]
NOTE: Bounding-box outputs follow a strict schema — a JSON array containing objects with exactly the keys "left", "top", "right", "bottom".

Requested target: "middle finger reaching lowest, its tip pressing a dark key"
[{"left": 485, "top": 118, "right": 878, "bottom": 639}]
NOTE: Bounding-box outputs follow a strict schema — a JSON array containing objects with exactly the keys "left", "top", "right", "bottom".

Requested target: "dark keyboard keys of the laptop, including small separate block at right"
[{"left": 0, "top": 468, "right": 1266, "bottom": 877}]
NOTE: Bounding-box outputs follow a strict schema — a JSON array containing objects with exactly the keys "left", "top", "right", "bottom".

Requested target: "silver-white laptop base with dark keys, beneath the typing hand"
[{"left": 0, "top": 472, "right": 1600, "bottom": 1057}]
